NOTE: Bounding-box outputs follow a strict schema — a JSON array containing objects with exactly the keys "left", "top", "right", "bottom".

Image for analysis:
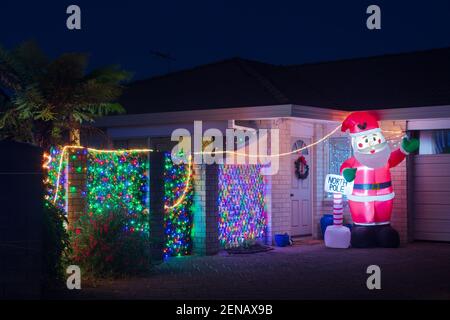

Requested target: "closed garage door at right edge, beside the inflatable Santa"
[{"left": 413, "top": 154, "right": 450, "bottom": 241}]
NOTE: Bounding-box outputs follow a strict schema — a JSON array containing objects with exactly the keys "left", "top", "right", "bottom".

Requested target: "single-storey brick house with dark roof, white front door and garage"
[{"left": 97, "top": 48, "right": 450, "bottom": 252}]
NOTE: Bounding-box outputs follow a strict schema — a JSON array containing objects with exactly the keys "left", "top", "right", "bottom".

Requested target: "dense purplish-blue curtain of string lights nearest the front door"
[{"left": 218, "top": 165, "right": 267, "bottom": 248}]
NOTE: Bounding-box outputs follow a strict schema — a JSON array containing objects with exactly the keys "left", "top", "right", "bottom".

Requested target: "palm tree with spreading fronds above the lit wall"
[{"left": 0, "top": 42, "right": 130, "bottom": 148}]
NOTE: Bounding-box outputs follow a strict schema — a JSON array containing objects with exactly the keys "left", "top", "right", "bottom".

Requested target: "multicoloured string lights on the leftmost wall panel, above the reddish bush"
[{"left": 43, "top": 146, "right": 151, "bottom": 231}]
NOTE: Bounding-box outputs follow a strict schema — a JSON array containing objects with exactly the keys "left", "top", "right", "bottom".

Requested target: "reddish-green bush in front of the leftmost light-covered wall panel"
[{"left": 70, "top": 210, "right": 150, "bottom": 277}]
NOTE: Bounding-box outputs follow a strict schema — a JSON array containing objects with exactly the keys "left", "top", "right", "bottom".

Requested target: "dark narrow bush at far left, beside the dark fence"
[{"left": 42, "top": 201, "right": 69, "bottom": 283}]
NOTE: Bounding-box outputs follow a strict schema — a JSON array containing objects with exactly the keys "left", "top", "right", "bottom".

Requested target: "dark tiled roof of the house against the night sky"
[{"left": 121, "top": 48, "right": 450, "bottom": 114}]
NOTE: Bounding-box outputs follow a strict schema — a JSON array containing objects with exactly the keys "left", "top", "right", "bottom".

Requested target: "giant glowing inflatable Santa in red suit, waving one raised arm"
[{"left": 341, "top": 111, "right": 419, "bottom": 248}]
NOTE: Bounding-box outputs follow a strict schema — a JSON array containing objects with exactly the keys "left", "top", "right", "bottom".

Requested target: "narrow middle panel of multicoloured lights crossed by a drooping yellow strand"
[{"left": 164, "top": 153, "right": 194, "bottom": 258}]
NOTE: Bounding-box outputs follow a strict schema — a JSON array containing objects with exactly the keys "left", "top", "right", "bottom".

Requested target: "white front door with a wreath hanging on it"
[{"left": 290, "top": 137, "right": 312, "bottom": 236}]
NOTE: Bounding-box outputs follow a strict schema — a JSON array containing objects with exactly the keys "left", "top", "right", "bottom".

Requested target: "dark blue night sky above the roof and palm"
[{"left": 0, "top": 0, "right": 450, "bottom": 79}]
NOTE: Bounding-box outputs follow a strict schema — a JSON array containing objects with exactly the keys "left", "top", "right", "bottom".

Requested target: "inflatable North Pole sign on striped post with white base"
[{"left": 324, "top": 174, "right": 353, "bottom": 249}]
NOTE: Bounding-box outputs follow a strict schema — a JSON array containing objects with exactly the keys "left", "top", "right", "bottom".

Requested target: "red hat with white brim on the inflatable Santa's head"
[{"left": 341, "top": 111, "right": 381, "bottom": 137}]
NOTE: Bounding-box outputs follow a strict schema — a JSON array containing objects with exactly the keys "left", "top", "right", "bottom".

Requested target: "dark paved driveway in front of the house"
[{"left": 53, "top": 243, "right": 450, "bottom": 299}]
